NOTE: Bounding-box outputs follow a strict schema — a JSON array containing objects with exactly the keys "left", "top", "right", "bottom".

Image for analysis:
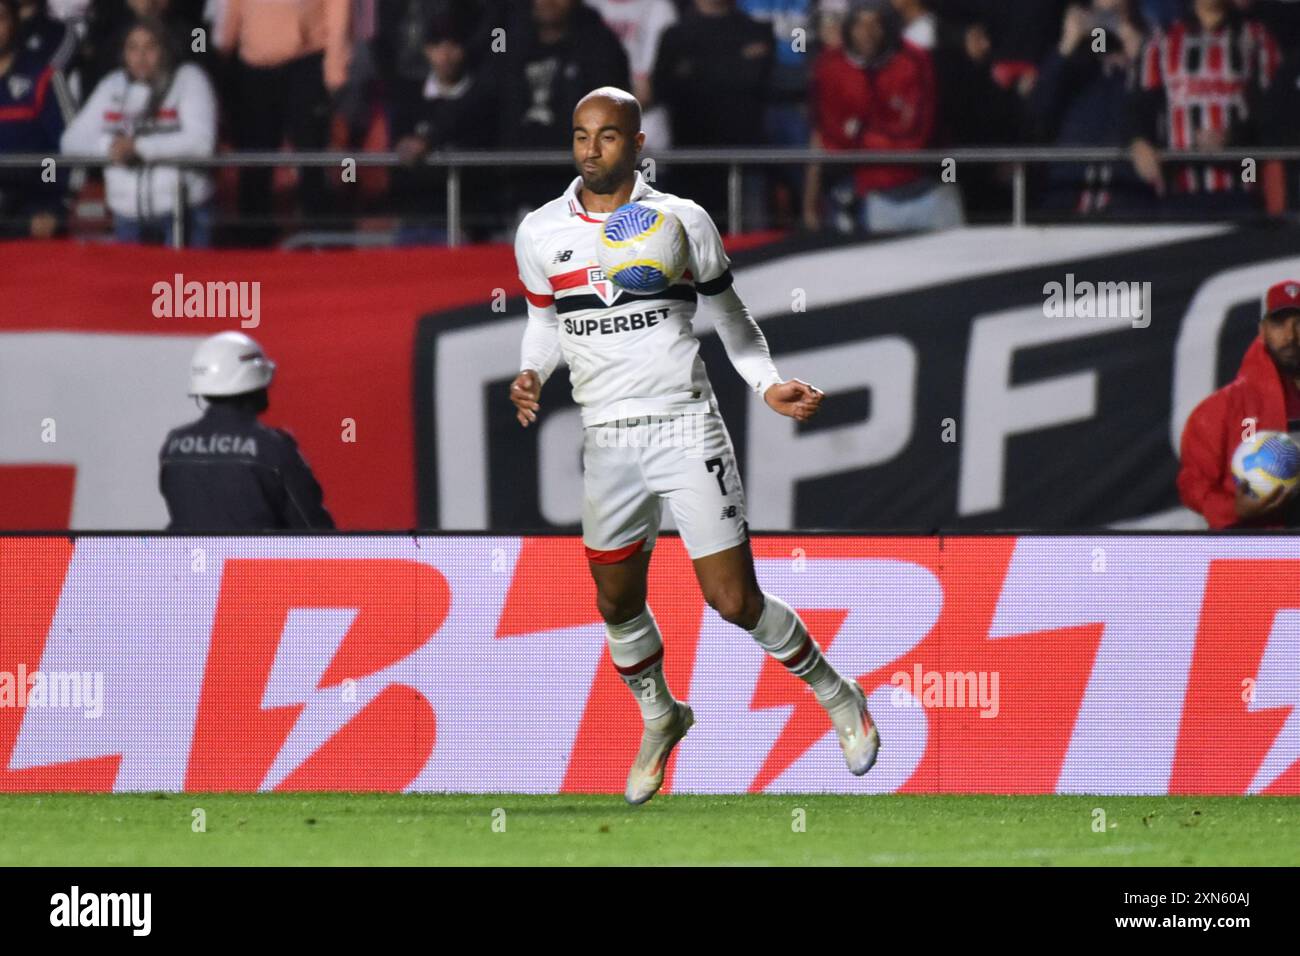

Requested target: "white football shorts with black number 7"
[{"left": 582, "top": 411, "right": 749, "bottom": 564}]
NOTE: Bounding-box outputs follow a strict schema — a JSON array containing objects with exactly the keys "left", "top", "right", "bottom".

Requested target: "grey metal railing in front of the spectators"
[{"left": 0, "top": 146, "right": 1300, "bottom": 247}]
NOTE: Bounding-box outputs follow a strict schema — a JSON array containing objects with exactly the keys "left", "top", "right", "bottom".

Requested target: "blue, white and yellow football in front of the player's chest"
[{"left": 597, "top": 203, "right": 689, "bottom": 293}]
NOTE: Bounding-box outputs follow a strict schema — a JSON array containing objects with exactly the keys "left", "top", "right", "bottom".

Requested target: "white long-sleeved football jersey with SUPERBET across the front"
[{"left": 515, "top": 172, "right": 780, "bottom": 425}]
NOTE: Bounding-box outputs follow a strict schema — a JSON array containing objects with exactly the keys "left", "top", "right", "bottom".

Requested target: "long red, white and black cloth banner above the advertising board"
[{"left": 0, "top": 225, "right": 1300, "bottom": 533}]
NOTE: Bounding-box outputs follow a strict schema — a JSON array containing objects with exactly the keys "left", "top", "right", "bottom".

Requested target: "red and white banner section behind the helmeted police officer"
[{"left": 0, "top": 233, "right": 772, "bottom": 531}]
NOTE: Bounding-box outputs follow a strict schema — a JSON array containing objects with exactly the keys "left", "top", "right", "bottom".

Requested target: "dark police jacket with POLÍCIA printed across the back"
[{"left": 159, "top": 405, "right": 334, "bottom": 531}]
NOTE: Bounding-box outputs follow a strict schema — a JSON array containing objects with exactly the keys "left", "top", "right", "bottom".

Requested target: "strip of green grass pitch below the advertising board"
[{"left": 0, "top": 793, "right": 1300, "bottom": 866}]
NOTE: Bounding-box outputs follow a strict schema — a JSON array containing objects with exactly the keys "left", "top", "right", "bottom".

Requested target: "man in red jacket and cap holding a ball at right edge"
[{"left": 1178, "top": 280, "right": 1300, "bottom": 528}]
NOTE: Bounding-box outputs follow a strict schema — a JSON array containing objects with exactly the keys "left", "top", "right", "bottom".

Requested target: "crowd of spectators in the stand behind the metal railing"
[{"left": 0, "top": 0, "right": 1300, "bottom": 245}]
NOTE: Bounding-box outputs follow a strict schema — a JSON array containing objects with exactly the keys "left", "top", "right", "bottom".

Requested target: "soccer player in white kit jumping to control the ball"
[{"left": 510, "top": 87, "right": 880, "bottom": 804}]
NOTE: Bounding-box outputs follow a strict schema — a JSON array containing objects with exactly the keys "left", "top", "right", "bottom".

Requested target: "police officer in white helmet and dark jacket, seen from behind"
[{"left": 159, "top": 332, "right": 334, "bottom": 531}]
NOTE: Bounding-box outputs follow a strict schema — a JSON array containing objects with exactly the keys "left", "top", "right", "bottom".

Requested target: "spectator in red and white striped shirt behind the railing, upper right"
[{"left": 1131, "top": 0, "right": 1281, "bottom": 213}]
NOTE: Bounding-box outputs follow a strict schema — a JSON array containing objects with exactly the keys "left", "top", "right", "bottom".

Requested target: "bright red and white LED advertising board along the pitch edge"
[{"left": 0, "top": 536, "right": 1300, "bottom": 795}]
